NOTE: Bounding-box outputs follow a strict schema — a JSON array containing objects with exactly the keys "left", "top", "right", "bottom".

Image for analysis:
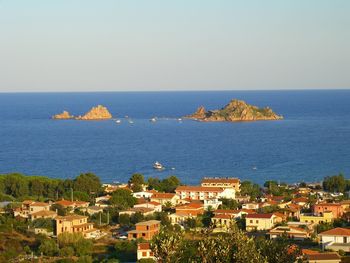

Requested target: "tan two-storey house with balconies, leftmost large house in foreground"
[{"left": 55, "top": 215, "right": 94, "bottom": 237}]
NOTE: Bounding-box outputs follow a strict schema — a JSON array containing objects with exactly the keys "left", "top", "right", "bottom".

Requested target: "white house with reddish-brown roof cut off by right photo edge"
[{"left": 319, "top": 227, "right": 350, "bottom": 252}]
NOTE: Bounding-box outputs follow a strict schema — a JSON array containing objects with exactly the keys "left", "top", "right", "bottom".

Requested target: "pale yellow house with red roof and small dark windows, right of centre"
[{"left": 245, "top": 213, "right": 282, "bottom": 232}]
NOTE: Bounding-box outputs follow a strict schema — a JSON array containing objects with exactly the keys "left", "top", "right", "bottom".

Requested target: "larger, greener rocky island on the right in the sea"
[{"left": 184, "top": 99, "right": 283, "bottom": 122}]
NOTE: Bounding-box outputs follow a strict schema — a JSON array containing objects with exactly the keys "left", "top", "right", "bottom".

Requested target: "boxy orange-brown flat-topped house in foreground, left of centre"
[{"left": 128, "top": 220, "right": 160, "bottom": 240}]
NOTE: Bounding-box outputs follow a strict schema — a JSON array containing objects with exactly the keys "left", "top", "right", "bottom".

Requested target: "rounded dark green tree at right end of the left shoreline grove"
[{"left": 73, "top": 173, "right": 101, "bottom": 194}]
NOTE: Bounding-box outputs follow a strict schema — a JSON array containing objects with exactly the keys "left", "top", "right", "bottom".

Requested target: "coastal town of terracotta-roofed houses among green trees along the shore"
[{"left": 0, "top": 174, "right": 350, "bottom": 263}]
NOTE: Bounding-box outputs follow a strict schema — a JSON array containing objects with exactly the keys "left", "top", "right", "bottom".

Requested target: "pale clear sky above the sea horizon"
[{"left": 0, "top": 0, "right": 350, "bottom": 92}]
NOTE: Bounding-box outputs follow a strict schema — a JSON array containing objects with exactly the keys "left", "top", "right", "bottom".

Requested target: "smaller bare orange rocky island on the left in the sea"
[{"left": 52, "top": 105, "right": 112, "bottom": 121}]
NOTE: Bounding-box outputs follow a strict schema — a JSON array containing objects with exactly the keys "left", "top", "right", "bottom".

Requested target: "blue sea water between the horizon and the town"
[{"left": 0, "top": 90, "right": 350, "bottom": 184}]
